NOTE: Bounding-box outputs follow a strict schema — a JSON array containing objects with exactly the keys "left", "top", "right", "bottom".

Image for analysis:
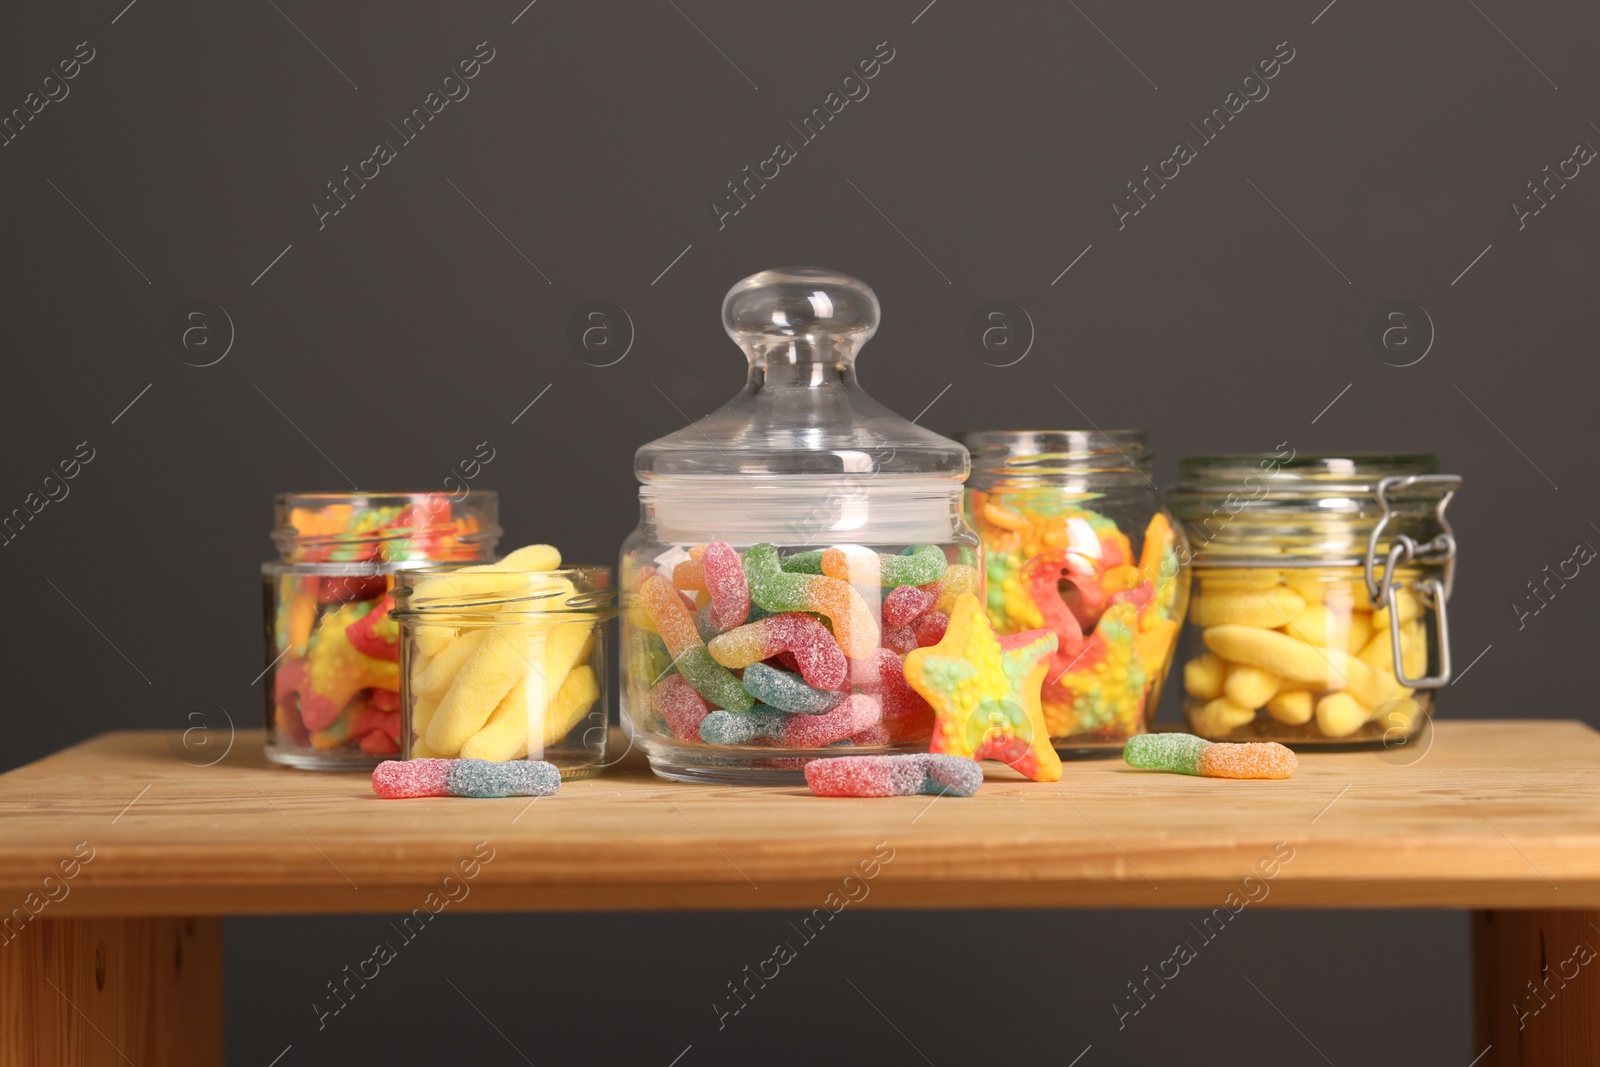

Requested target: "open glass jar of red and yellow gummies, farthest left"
[{"left": 261, "top": 490, "right": 501, "bottom": 769}]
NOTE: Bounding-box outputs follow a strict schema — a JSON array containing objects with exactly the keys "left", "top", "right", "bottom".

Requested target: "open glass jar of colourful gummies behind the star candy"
[{"left": 962, "top": 430, "right": 1189, "bottom": 750}]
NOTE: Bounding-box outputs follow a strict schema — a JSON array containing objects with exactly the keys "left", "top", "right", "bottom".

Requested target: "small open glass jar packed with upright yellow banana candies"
[{"left": 394, "top": 565, "right": 616, "bottom": 779}]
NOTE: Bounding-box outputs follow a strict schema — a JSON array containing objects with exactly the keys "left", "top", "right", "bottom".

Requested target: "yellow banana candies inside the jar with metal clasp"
[{"left": 1184, "top": 566, "right": 1427, "bottom": 739}]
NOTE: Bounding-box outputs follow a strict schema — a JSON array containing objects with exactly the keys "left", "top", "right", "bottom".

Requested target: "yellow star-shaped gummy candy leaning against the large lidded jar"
[{"left": 906, "top": 593, "right": 1061, "bottom": 782}]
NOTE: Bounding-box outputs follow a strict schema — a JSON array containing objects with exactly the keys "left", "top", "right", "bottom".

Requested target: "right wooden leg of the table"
[{"left": 1472, "top": 910, "right": 1600, "bottom": 1067}]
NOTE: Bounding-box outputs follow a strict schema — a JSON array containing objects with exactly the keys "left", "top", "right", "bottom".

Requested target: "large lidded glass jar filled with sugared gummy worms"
[{"left": 621, "top": 267, "right": 982, "bottom": 784}]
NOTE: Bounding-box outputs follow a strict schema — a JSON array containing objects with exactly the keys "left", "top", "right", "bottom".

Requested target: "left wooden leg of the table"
[{"left": 0, "top": 917, "right": 222, "bottom": 1067}]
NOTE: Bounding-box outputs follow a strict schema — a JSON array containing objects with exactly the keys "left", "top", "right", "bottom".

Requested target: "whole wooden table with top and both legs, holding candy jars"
[{"left": 0, "top": 721, "right": 1600, "bottom": 1067}]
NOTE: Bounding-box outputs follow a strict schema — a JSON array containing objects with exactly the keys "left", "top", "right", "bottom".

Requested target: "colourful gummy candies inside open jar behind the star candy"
[{"left": 968, "top": 490, "right": 1182, "bottom": 741}]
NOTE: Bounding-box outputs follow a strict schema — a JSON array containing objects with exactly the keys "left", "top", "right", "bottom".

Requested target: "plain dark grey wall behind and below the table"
[{"left": 0, "top": 0, "right": 1600, "bottom": 1067}]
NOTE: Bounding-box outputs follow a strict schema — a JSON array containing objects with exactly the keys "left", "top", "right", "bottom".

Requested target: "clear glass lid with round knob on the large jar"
[{"left": 634, "top": 267, "right": 968, "bottom": 485}]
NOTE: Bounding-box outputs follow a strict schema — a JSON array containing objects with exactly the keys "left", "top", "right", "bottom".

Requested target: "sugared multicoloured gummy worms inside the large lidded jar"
[{"left": 629, "top": 541, "right": 979, "bottom": 749}]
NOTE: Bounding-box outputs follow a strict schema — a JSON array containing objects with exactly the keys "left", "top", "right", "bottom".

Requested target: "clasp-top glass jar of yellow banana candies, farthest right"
[{"left": 1171, "top": 448, "right": 1461, "bottom": 745}]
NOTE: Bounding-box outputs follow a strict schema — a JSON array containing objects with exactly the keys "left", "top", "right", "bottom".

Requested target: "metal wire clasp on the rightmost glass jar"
[{"left": 1366, "top": 474, "right": 1461, "bottom": 689}]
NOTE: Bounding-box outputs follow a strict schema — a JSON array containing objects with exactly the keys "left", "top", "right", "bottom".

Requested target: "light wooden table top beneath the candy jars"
[{"left": 0, "top": 720, "right": 1600, "bottom": 918}]
